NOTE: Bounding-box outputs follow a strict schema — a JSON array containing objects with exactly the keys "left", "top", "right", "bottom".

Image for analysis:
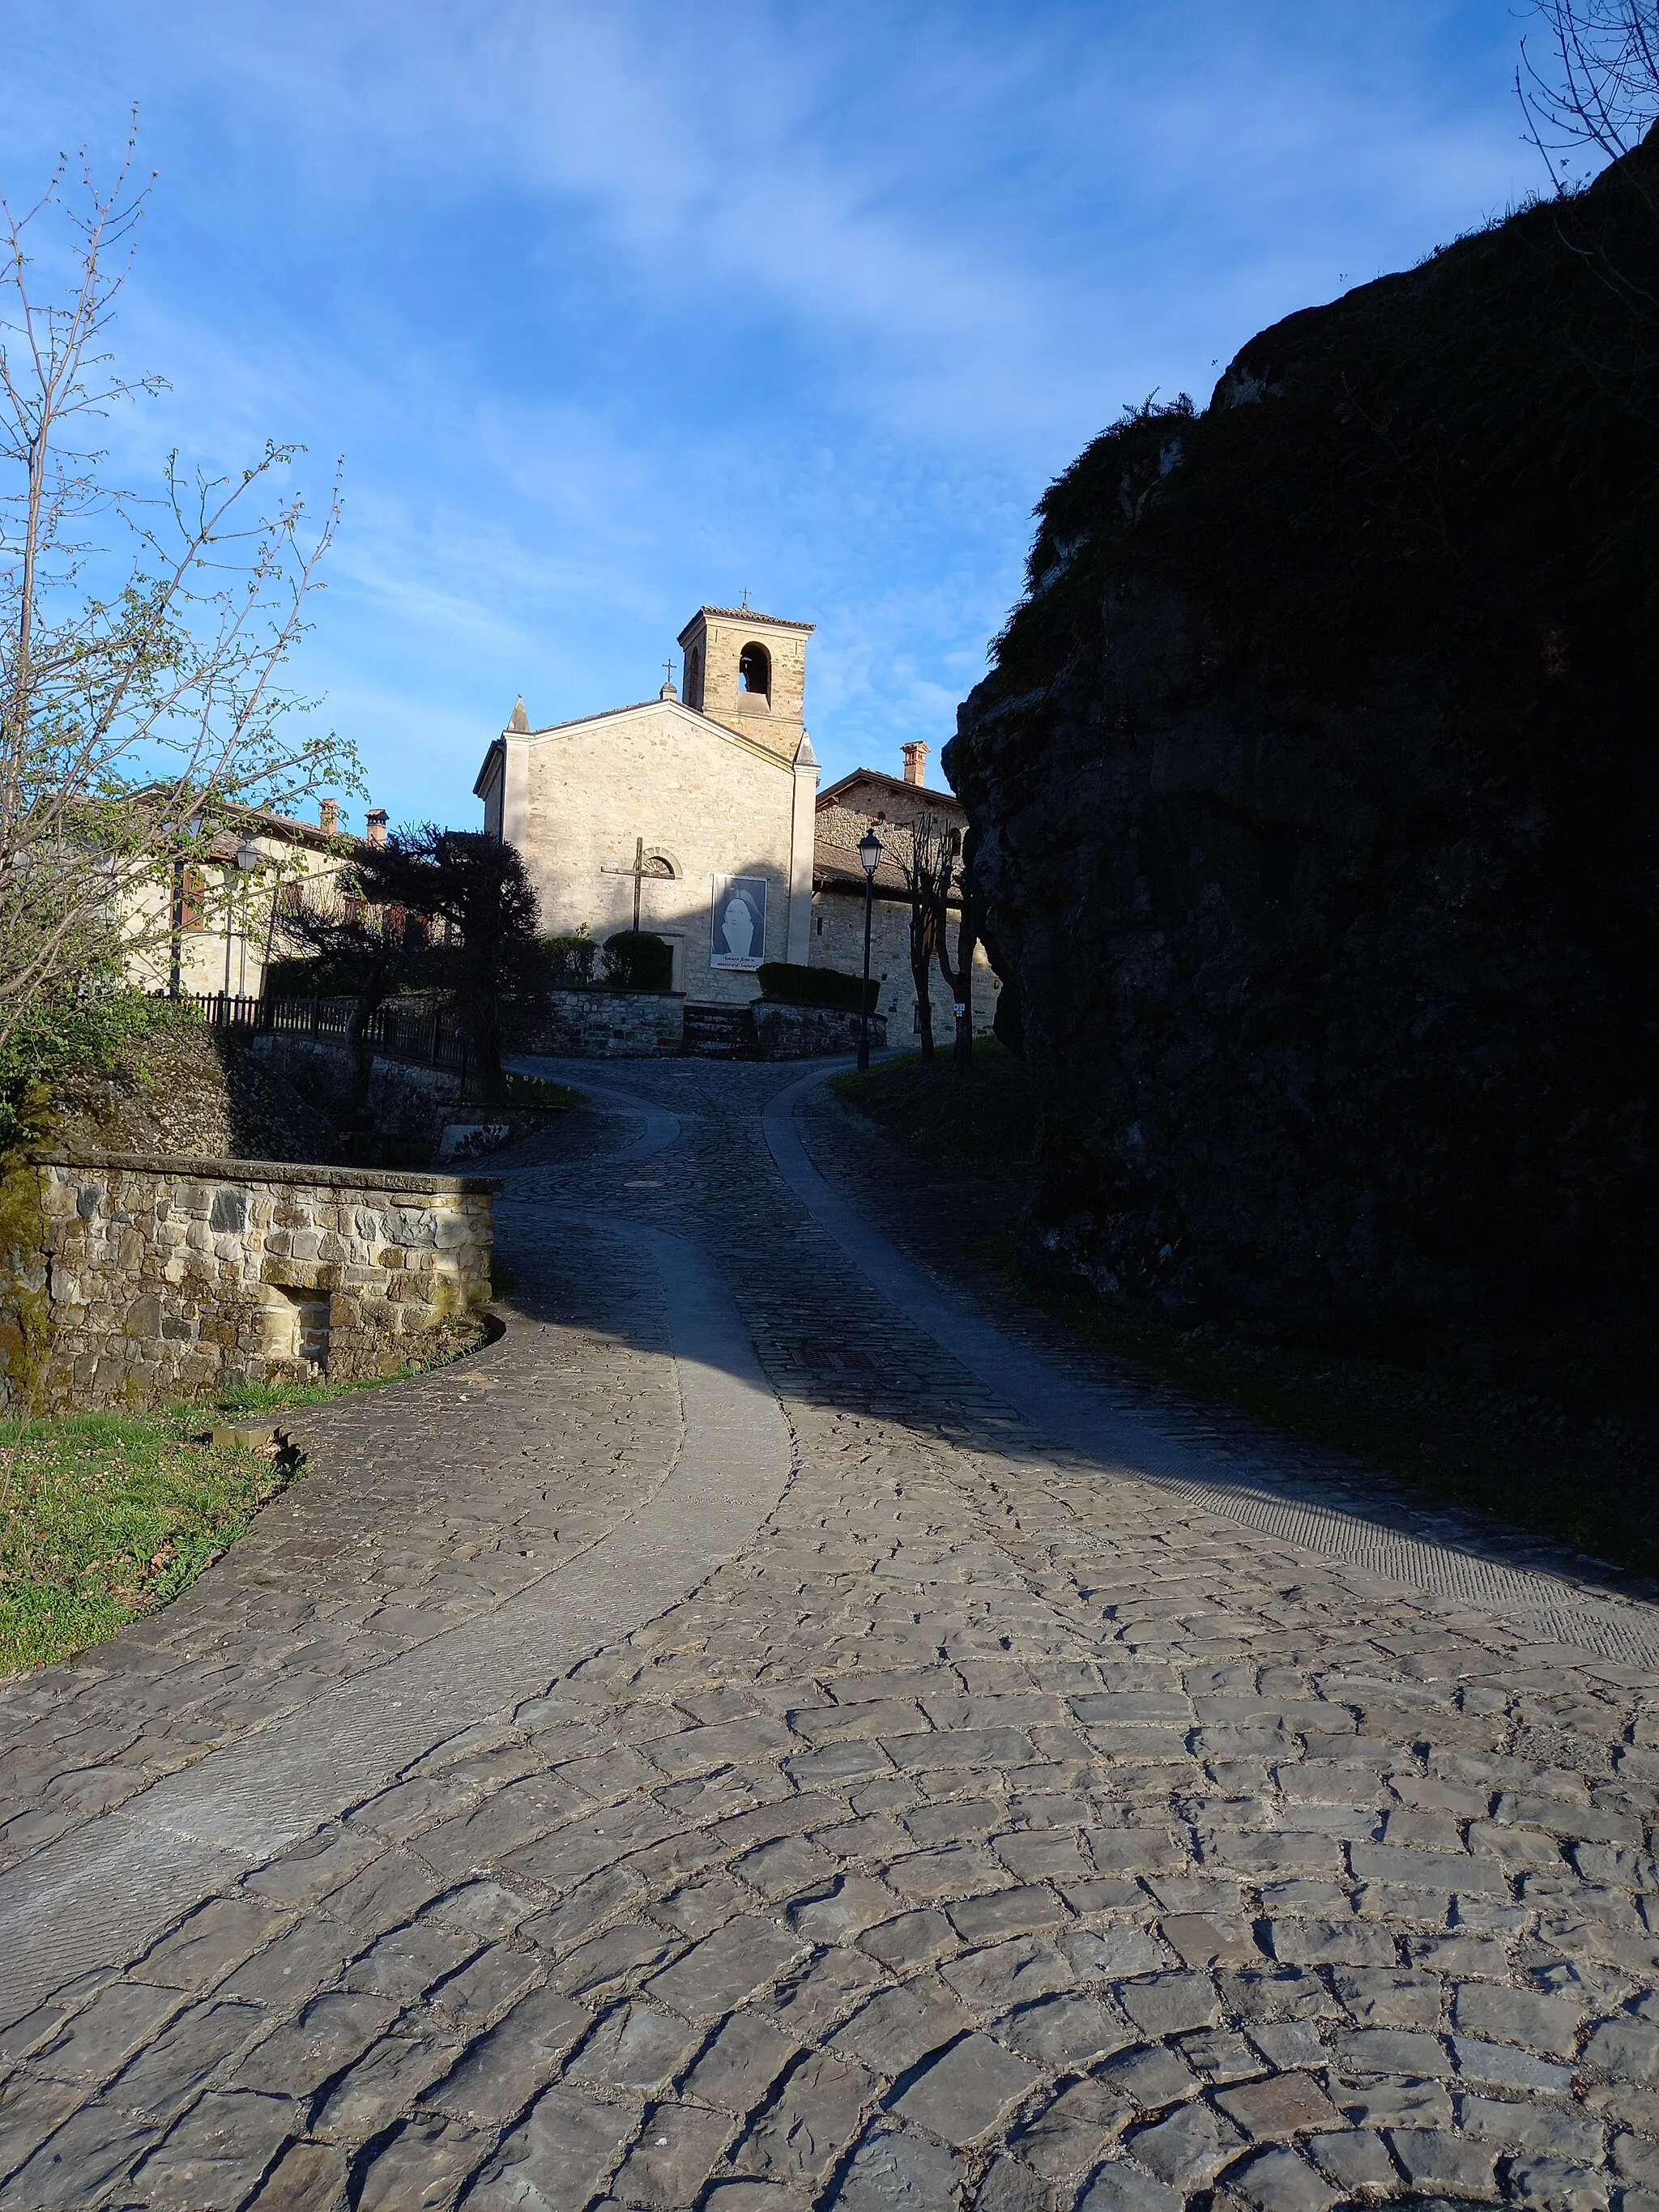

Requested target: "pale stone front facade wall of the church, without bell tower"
[{"left": 522, "top": 710, "right": 794, "bottom": 1004}]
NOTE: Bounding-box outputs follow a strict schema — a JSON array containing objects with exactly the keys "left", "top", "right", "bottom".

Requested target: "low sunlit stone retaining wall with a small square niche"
[{"left": 0, "top": 1153, "right": 500, "bottom": 1411}]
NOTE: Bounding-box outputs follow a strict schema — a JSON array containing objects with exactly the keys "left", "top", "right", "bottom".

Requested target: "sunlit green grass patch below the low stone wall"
[{"left": 0, "top": 1367, "right": 435, "bottom": 1677}]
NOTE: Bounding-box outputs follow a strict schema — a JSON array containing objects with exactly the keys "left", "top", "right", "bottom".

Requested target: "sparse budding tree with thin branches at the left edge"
[{"left": 0, "top": 127, "right": 360, "bottom": 1046}]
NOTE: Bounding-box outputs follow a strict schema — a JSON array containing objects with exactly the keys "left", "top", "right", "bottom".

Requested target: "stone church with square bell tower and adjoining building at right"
[{"left": 473, "top": 606, "right": 996, "bottom": 1026}]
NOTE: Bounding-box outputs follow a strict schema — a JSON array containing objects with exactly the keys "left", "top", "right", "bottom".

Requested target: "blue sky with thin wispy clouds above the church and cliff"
[{"left": 0, "top": 0, "right": 1544, "bottom": 827}]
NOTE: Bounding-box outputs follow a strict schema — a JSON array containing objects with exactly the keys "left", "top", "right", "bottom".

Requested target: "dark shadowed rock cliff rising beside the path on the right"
[{"left": 945, "top": 139, "right": 1659, "bottom": 1347}]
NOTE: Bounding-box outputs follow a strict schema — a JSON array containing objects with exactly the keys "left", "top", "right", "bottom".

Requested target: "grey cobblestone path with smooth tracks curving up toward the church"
[{"left": 0, "top": 1064, "right": 1659, "bottom": 2212}]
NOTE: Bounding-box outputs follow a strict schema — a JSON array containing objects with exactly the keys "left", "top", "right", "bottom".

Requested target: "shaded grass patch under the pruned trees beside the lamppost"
[{"left": 830, "top": 1038, "right": 1038, "bottom": 1177}]
